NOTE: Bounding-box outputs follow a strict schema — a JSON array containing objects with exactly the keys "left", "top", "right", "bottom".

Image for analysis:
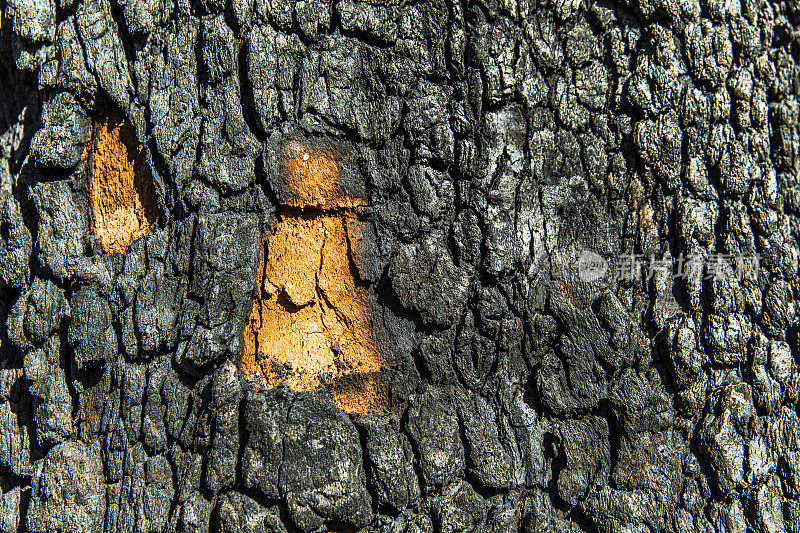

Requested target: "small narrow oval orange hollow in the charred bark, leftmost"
[{"left": 87, "top": 115, "right": 158, "bottom": 253}]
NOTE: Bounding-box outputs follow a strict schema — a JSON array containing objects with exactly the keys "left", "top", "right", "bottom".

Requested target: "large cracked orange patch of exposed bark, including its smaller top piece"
[{"left": 241, "top": 141, "right": 386, "bottom": 413}]
